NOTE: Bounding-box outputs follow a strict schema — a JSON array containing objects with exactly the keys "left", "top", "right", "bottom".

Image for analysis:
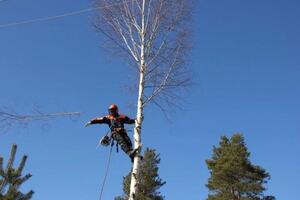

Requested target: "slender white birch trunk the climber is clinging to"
[{"left": 129, "top": 0, "right": 146, "bottom": 200}]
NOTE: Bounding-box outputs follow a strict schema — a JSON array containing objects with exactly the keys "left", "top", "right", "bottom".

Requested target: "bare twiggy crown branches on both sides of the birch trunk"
[{"left": 97, "top": 0, "right": 191, "bottom": 109}]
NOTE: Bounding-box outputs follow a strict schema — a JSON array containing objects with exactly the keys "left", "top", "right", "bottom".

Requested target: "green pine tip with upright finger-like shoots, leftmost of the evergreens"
[{"left": 0, "top": 144, "right": 33, "bottom": 200}]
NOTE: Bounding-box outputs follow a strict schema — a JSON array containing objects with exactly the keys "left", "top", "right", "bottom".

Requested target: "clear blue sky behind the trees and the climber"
[{"left": 0, "top": 0, "right": 300, "bottom": 200}]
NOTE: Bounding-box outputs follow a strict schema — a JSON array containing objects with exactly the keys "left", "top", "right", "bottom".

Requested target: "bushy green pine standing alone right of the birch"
[{"left": 206, "top": 134, "right": 275, "bottom": 200}]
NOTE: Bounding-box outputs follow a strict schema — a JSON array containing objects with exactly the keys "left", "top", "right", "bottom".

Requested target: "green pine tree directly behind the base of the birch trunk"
[{"left": 115, "top": 148, "right": 166, "bottom": 200}]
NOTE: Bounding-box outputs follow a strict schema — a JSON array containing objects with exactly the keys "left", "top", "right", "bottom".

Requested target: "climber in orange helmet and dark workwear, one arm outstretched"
[{"left": 85, "top": 104, "right": 136, "bottom": 162}]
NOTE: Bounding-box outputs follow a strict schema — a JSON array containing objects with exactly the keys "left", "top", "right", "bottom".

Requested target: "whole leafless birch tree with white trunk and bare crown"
[{"left": 95, "top": 0, "right": 193, "bottom": 200}]
